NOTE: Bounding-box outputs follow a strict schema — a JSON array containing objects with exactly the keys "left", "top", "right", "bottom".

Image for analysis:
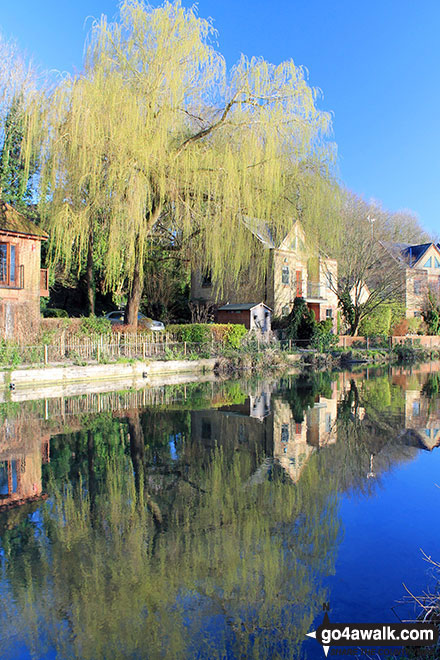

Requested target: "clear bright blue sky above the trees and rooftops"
[{"left": 0, "top": 0, "right": 440, "bottom": 234}]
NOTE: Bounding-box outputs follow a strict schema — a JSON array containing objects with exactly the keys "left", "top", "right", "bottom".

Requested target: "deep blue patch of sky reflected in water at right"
[{"left": 304, "top": 450, "right": 440, "bottom": 658}]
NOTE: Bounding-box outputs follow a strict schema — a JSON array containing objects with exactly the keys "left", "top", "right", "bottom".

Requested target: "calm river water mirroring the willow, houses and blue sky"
[{"left": 0, "top": 365, "right": 440, "bottom": 660}]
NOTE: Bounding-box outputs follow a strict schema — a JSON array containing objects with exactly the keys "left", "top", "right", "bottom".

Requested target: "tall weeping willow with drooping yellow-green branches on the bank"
[{"left": 29, "top": 0, "right": 333, "bottom": 324}]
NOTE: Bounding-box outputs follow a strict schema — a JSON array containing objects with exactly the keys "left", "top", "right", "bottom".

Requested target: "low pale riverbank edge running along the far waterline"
[{"left": 0, "top": 346, "right": 439, "bottom": 394}]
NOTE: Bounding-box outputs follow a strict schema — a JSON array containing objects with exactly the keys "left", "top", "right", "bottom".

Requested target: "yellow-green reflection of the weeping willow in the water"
[{"left": 1, "top": 414, "right": 339, "bottom": 658}]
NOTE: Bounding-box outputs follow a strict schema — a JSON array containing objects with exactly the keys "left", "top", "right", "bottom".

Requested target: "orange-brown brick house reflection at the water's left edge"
[{"left": 0, "top": 418, "right": 50, "bottom": 511}]
